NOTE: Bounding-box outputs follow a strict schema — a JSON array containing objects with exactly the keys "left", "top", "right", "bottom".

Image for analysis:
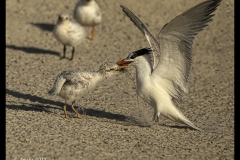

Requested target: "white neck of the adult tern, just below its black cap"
[{"left": 135, "top": 55, "right": 152, "bottom": 80}]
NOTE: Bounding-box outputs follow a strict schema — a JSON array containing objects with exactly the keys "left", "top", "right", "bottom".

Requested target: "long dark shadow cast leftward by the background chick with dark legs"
[{"left": 6, "top": 45, "right": 60, "bottom": 57}]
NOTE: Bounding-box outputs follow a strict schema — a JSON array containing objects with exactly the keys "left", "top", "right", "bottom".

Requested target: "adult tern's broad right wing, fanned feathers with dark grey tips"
[{"left": 152, "top": 0, "right": 221, "bottom": 102}]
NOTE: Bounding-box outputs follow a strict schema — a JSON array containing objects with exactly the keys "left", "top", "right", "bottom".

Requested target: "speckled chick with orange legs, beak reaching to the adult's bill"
[{"left": 48, "top": 62, "right": 119, "bottom": 119}]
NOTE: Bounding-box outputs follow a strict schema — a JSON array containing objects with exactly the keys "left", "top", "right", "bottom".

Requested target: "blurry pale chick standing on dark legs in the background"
[{"left": 53, "top": 13, "right": 86, "bottom": 60}]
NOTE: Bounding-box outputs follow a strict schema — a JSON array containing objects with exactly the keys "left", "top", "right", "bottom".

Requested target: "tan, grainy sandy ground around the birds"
[{"left": 6, "top": 0, "right": 234, "bottom": 160}]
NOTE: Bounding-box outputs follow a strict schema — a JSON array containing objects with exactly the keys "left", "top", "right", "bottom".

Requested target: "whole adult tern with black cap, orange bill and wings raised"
[{"left": 117, "top": 0, "right": 221, "bottom": 131}]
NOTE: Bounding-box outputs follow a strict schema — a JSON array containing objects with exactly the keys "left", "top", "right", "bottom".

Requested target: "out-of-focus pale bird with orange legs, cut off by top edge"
[{"left": 74, "top": 0, "right": 102, "bottom": 40}]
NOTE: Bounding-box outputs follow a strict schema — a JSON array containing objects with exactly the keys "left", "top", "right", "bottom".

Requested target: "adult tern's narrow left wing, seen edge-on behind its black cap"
[{"left": 120, "top": 5, "right": 160, "bottom": 69}]
